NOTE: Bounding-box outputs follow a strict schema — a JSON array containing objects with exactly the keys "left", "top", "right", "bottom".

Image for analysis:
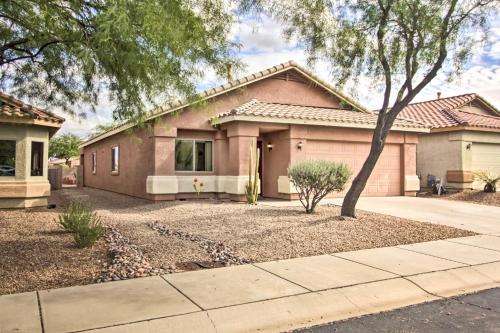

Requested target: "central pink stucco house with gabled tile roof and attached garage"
[{"left": 80, "top": 62, "right": 429, "bottom": 201}]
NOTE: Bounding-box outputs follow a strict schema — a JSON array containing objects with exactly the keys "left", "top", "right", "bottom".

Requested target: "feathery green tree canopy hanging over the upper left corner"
[{"left": 0, "top": 0, "right": 238, "bottom": 119}]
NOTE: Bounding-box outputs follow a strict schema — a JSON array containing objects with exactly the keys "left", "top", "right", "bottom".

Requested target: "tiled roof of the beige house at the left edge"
[{"left": 0, "top": 92, "right": 64, "bottom": 123}]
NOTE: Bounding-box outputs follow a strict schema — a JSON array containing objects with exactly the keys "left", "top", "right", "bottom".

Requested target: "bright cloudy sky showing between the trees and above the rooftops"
[{"left": 61, "top": 17, "right": 500, "bottom": 137}]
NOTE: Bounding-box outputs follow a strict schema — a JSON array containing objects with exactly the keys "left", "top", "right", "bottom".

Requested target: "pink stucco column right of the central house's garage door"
[{"left": 401, "top": 133, "right": 420, "bottom": 196}]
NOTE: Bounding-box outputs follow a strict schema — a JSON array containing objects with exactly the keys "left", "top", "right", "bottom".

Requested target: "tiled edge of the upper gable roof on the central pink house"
[{"left": 80, "top": 60, "right": 371, "bottom": 147}]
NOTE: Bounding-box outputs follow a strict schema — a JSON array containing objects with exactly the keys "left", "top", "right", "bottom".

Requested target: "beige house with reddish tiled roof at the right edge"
[{"left": 401, "top": 94, "right": 500, "bottom": 189}]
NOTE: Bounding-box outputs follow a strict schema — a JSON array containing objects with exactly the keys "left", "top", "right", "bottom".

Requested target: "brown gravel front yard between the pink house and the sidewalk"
[{"left": 0, "top": 188, "right": 473, "bottom": 294}]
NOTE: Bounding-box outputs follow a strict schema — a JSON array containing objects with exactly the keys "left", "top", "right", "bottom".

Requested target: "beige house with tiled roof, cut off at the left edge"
[{"left": 0, "top": 93, "right": 64, "bottom": 208}]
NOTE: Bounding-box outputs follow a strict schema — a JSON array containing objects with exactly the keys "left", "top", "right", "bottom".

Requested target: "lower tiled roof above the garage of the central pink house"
[{"left": 213, "top": 99, "right": 428, "bottom": 129}]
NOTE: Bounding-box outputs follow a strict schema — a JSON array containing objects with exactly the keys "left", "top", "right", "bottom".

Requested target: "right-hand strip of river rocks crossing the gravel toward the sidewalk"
[{"left": 148, "top": 221, "right": 250, "bottom": 266}]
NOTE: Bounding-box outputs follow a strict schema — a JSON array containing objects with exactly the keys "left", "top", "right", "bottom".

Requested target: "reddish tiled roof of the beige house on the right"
[{"left": 400, "top": 94, "right": 500, "bottom": 129}]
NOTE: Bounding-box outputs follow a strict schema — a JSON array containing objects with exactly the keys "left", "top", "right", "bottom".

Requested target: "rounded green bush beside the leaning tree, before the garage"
[{"left": 288, "top": 160, "right": 352, "bottom": 214}]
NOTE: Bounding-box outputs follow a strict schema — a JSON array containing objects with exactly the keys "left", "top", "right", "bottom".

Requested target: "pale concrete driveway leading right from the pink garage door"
[{"left": 329, "top": 197, "right": 500, "bottom": 234}]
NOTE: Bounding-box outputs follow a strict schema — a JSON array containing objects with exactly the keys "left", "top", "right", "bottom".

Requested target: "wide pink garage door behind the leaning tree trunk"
[{"left": 306, "top": 141, "right": 402, "bottom": 196}]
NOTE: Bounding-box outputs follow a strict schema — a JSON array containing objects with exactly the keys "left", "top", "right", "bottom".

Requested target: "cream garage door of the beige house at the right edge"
[{"left": 472, "top": 142, "right": 500, "bottom": 189}]
